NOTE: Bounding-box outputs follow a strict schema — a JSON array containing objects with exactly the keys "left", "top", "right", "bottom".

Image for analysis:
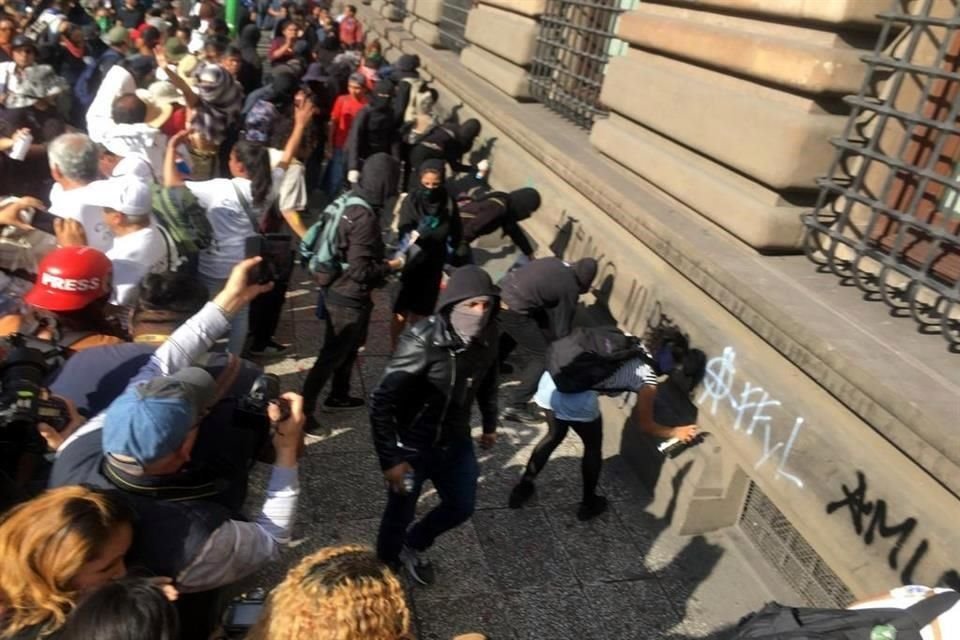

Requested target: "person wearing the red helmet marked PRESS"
[{"left": 0, "top": 247, "right": 124, "bottom": 351}]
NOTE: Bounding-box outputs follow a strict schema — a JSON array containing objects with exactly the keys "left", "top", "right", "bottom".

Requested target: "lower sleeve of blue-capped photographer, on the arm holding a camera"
[{"left": 176, "top": 467, "right": 300, "bottom": 593}]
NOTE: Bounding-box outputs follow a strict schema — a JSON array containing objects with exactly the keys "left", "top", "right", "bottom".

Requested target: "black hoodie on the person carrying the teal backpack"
[{"left": 326, "top": 153, "right": 400, "bottom": 308}]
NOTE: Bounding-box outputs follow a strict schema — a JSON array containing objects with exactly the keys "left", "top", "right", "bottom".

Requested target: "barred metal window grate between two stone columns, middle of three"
[{"left": 530, "top": 0, "right": 624, "bottom": 129}]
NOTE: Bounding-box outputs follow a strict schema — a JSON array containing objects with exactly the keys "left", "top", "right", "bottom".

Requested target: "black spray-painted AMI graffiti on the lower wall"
[{"left": 827, "top": 471, "right": 960, "bottom": 589}]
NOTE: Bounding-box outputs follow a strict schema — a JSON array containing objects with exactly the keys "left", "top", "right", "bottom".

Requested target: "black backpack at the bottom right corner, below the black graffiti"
[{"left": 733, "top": 591, "right": 960, "bottom": 640}]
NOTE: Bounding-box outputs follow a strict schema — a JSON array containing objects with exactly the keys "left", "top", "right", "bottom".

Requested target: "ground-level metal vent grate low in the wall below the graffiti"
[{"left": 740, "top": 482, "right": 853, "bottom": 607}]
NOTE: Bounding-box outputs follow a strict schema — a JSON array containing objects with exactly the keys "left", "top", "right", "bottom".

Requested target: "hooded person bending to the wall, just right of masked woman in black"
[{"left": 460, "top": 187, "right": 540, "bottom": 262}]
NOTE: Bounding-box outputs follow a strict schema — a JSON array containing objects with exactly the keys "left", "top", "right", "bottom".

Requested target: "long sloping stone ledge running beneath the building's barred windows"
[{"left": 358, "top": 7, "right": 960, "bottom": 496}]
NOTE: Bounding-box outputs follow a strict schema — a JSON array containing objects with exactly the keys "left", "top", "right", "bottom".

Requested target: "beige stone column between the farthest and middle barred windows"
[{"left": 460, "top": 0, "right": 547, "bottom": 99}]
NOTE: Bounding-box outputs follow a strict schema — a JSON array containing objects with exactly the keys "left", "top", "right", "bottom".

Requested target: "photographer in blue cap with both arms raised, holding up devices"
[{"left": 49, "top": 258, "right": 304, "bottom": 593}]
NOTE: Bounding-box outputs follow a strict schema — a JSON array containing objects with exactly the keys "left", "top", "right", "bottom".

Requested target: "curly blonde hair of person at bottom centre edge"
[{"left": 246, "top": 545, "right": 414, "bottom": 640}]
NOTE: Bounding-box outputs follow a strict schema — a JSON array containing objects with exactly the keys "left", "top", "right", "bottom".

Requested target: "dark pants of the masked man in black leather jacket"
[{"left": 377, "top": 438, "right": 480, "bottom": 563}]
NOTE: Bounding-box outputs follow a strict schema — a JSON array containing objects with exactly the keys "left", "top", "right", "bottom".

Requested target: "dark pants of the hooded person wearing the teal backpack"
[{"left": 303, "top": 301, "right": 373, "bottom": 416}]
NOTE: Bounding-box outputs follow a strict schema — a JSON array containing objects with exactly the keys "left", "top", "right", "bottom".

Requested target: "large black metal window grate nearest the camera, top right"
[{"left": 804, "top": 0, "right": 960, "bottom": 350}]
